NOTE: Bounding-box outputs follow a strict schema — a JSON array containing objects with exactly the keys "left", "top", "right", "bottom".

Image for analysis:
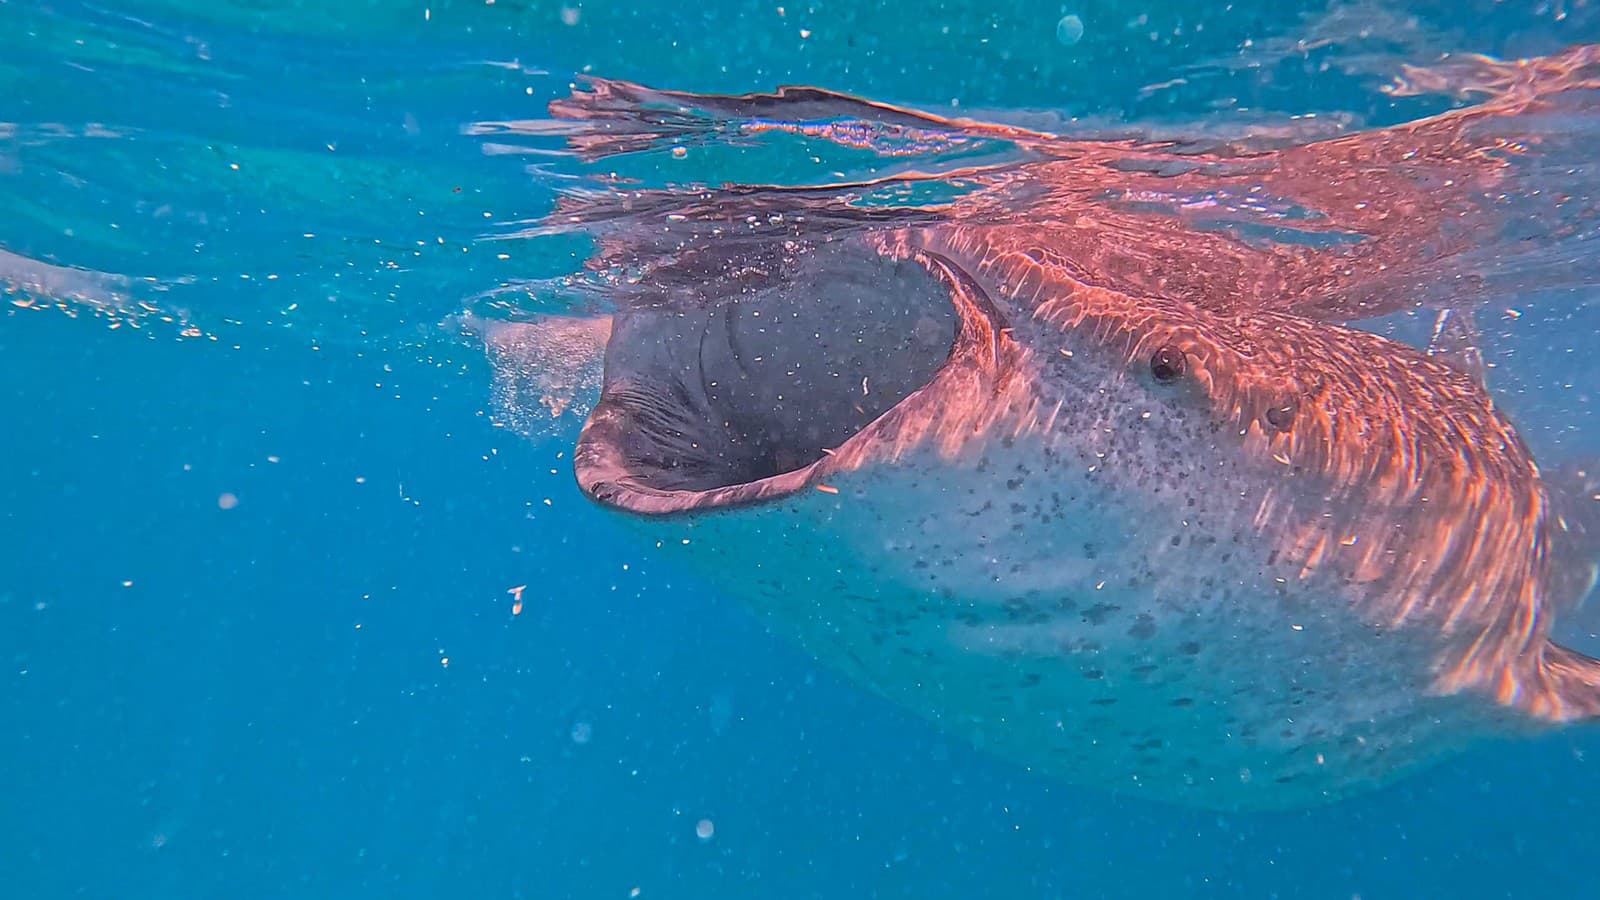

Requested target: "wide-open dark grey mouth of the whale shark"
[{"left": 574, "top": 242, "right": 987, "bottom": 512}]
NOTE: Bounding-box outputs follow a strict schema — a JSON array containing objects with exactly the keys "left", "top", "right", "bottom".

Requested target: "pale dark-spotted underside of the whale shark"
[{"left": 633, "top": 440, "right": 1504, "bottom": 809}]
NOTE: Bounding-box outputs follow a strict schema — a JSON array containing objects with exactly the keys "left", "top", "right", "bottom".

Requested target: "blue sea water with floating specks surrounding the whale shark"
[{"left": 9, "top": 0, "right": 1600, "bottom": 898}]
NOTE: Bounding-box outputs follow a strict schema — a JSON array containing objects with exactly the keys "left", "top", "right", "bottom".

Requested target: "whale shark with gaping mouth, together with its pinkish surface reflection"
[{"left": 480, "top": 48, "right": 1600, "bottom": 809}]
